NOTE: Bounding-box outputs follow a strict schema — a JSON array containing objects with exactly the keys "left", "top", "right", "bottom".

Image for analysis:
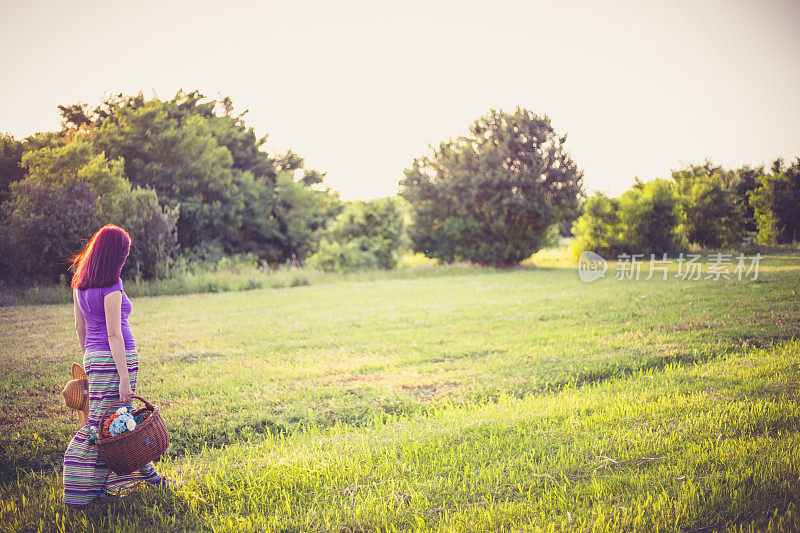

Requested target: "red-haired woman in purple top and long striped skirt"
[{"left": 64, "top": 224, "right": 166, "bottom": 507}]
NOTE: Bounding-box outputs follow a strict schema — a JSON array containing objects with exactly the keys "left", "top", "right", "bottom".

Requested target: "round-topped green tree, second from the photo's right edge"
[{"left": 672, "top": 161, "right": 745, "bottom": 247}]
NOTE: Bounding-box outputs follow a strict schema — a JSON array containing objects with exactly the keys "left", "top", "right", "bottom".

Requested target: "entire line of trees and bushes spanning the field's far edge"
[{"left": 0, "top": 90, "right": 800, "bottom": 282}]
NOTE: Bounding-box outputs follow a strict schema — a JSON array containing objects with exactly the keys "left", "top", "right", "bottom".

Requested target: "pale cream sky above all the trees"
[{"left": 0, "top": 0, "right": 800, "bottom": 199}]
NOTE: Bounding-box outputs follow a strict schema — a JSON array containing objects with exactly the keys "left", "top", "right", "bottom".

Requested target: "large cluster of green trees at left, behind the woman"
[{"left": 0, "top": 91, "right": 344, "bottom": 280}]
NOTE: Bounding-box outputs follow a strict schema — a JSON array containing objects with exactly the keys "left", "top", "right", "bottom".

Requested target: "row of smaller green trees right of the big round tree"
[{"left": 573, "top": 158, "right": 800, "bottom": 258}]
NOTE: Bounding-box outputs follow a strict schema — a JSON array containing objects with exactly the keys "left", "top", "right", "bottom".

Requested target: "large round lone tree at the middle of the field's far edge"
[{"left": 400, "top": 108, "right": 583, "bottom": 266}]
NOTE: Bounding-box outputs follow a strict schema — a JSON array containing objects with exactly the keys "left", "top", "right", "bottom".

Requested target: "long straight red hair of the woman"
[{"left": 70, "top": 224, "right": 131, "bottom": 291}]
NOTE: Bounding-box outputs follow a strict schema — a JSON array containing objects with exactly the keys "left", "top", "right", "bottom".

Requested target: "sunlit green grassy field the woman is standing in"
[{"left": 0, "top": 251, "right": 800, "bottom": 531}]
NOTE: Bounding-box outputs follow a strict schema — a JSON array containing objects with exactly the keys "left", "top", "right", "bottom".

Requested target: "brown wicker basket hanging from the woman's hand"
[{"left": 96, "top": 396, "right": 169, "bottom": 475}]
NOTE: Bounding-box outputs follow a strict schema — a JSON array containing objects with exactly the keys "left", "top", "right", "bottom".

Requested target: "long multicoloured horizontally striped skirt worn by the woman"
[{"left": 64, "top": 350, "right": 161, "bottom": 506}]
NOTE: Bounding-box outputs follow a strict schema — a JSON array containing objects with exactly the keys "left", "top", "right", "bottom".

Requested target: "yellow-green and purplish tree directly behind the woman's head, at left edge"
[{"left": 0, "top": 138, "right": 177, "bottom": 281}]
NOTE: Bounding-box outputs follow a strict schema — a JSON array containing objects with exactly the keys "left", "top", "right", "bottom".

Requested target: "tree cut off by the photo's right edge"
[{"left": 750, "top": 158, "right": 800, "bottom": 244}]
